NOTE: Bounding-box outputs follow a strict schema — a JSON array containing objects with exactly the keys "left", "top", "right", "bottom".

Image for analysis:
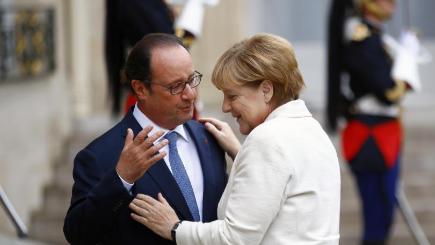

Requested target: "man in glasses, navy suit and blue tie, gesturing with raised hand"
[{"left": 64, "top": 34, "right": 227, "bottom": 245}]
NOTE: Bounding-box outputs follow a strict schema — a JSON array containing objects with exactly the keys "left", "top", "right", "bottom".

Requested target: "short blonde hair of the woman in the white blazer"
[{"left": 211, "top": 34, "right": 304, "bottom": 105}]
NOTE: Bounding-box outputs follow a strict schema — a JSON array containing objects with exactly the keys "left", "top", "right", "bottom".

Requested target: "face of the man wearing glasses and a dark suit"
[{"left": 139, "top": 46, "right": 197, "bottom": 129}]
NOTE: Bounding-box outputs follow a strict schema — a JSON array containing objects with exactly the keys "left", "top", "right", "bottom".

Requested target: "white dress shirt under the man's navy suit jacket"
[{"left": 119, "top": 104, "right": 204, "bottom": 220}]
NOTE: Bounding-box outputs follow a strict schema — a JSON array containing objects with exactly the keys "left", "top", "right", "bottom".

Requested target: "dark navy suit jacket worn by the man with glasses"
[{"left": 64, "top": 110, "right": 227, "bottom": 245}]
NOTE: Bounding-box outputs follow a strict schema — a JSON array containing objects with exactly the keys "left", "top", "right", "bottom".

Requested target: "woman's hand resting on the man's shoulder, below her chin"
[{"left": 199, "top": 118, "right": 240, "bottom": 160}]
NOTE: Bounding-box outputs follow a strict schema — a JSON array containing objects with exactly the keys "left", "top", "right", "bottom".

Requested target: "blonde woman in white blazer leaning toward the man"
[{"left": 130, "top": 34, "right": 340, "bottom": 245}]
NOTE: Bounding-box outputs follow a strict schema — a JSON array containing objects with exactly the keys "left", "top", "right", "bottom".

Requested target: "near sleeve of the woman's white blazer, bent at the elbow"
[{"left": 176, "top": 133, "right": 292, "bottom": 245}]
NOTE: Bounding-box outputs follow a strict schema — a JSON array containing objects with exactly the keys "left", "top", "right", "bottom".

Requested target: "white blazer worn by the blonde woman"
[{"left": 176, "top": 100, "right": 340, "bottom": 245}]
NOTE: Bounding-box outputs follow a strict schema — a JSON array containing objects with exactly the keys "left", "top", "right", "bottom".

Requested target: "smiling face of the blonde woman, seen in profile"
[{"left": 222, "top": 82, "right": 273, "bottom": 135}]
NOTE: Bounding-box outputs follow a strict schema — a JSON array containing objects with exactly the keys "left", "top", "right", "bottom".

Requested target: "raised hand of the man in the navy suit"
[{"left": 116, "top": 126, "right": 168, "bottom": 184}]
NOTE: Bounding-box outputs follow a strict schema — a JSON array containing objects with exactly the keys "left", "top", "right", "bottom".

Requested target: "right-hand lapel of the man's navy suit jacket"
[{"left": 185, "top": 121, "right": 216, "bottom": 221}]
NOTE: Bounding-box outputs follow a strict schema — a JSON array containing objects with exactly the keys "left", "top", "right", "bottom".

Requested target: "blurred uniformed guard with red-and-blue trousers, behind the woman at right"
[{"left": 327, "top": 0, "right": 421, "bottom": 244}]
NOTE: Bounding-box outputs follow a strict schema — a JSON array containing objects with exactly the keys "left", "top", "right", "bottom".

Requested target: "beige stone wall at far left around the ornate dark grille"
[{"left": 0, "top": 0, "right": 72, "bottom": 235}]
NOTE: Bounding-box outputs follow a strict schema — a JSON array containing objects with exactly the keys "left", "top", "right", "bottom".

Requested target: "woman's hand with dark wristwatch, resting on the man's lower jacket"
[{"left": 129, "top": 193, "right": 180, "bottom": 240}]
